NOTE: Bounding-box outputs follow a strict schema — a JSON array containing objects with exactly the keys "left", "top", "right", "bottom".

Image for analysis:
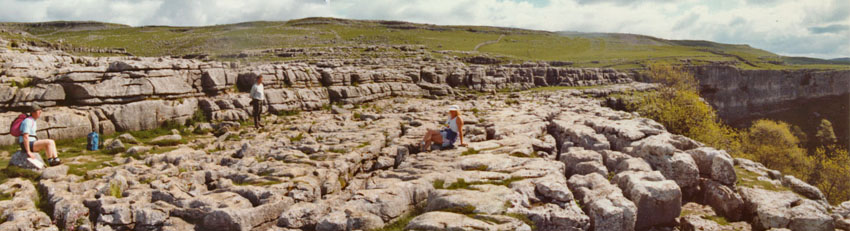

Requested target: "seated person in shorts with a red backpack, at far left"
[{"left": 18, "top": 105, "right": 62, "bottom": 166}]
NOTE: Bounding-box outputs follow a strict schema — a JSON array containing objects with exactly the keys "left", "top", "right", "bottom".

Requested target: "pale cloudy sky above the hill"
[{"left": 0, "top": 0, "right": 850, "bottom": 58}]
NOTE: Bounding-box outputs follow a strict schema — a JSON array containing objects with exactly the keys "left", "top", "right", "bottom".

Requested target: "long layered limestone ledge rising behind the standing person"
[{"left": 0, "top": 45, "right": 633, "bottom": 145}]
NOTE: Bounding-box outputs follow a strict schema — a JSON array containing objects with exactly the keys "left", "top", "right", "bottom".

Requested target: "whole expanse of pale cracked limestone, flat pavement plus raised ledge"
[{"left": 0, "top": 38, "right": 850, "bottom": 230}]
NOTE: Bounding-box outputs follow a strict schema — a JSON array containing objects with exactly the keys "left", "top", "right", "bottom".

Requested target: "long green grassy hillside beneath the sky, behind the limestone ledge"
[{"left": 0, "top": 18, "right": 850, "bottom": 69}]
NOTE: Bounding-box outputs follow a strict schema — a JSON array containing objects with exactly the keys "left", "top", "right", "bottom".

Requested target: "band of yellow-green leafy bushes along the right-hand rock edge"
[{"left": 613, "top": 65, "right": 850, "bottom": 204}]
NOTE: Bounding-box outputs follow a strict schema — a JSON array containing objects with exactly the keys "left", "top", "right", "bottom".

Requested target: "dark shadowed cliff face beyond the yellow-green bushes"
[{"left": 691, "top": 66, "right": 850, "bottom": 121}]
